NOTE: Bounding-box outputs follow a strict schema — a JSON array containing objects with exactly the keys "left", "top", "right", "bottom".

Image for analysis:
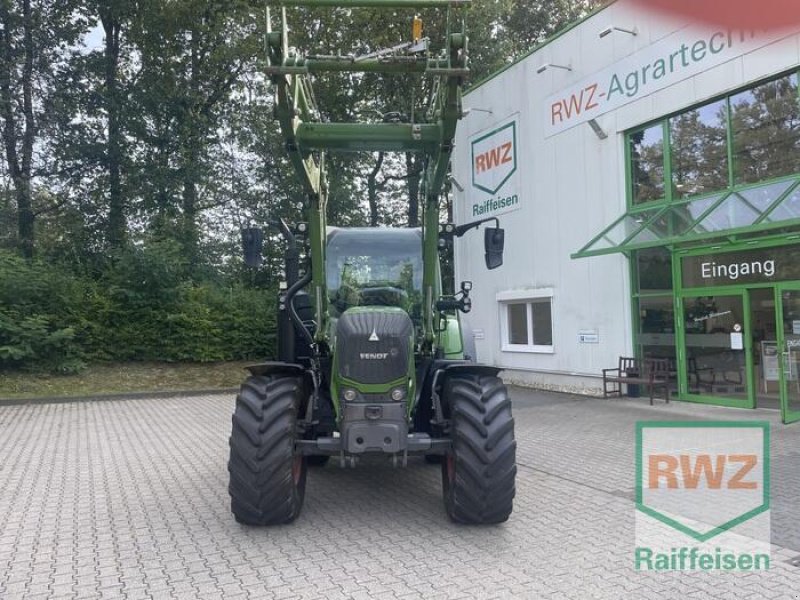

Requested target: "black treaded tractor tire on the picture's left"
[{"left": 228, "top": 376, "right": 306, "bottom": 525}]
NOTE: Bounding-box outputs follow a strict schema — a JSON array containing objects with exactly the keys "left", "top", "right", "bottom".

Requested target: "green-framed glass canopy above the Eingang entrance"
[{"left": 572, "top": 176, "right": 800, "bottom": 258}]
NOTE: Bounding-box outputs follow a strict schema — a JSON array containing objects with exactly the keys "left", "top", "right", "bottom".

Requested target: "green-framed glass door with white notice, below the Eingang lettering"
[{"left": 681, "top": 290, "right": 752, "bottom": 408}]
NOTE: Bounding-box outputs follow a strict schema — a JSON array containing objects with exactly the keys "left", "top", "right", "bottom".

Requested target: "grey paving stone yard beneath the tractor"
[{"left": 0, "top": 389, "right": 800, "bottom": 600}]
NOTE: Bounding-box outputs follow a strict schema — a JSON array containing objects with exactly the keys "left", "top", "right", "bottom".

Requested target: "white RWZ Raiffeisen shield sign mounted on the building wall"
[{"left": 464, "top": 114, "right": 521, "bottom": 222}]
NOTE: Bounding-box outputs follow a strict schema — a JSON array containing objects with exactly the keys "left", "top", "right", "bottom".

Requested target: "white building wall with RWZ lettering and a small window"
[{"left": 453, "top": 3, "right": 800, "bottom": 393}]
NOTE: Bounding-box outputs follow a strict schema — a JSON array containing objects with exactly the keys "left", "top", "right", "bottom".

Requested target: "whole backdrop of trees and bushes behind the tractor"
[{"left": 0, "top": 0, "right": 593, "bottom": 372}]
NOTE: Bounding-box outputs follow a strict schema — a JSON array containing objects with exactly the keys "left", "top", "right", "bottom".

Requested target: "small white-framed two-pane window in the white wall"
[{"left": 497, "top": 289, "right": 553, "bottom": 352}]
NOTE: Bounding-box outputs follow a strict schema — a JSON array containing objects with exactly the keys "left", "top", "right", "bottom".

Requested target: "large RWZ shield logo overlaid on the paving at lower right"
[{"left": 636, "top": 421, "right": 769, "bottom": 542}]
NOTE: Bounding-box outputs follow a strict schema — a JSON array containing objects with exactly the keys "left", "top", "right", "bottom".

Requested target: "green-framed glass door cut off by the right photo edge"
[{"left": 778, "top": 285, "right": 800, "bottom": 423}]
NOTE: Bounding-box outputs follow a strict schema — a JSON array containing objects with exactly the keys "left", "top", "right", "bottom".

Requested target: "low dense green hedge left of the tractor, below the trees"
[{"left": 0, "top": 243, "right": 275, "bottom": 373}]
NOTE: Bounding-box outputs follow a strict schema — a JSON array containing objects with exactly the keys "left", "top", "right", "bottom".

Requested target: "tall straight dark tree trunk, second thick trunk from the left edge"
[{"left": 100, "top": 7, "right": 127, "bottom": 248}]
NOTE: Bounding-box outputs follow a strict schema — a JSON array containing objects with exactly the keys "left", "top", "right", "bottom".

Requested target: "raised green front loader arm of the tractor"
[{"left": 266, "top": 0, "right": 470, "bottom": 354}]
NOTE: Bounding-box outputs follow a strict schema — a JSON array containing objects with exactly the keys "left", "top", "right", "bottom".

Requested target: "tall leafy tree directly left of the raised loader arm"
[{"left": 127, "top": 0, "right": 259, "bottom": 264}]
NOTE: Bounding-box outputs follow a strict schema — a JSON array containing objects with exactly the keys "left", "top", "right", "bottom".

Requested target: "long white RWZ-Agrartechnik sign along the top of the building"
[{"left": 543, "top": 27, "right": 790, "bottom": 137}]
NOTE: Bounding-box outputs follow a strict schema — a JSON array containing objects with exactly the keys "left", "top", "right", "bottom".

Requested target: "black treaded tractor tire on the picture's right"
[{"left": 442, "top": 373, "right": 517, "bottom": 524}]
